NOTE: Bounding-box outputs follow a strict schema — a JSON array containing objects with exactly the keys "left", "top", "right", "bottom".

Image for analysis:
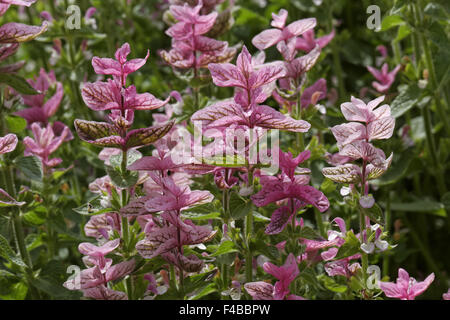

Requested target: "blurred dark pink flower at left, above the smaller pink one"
[{"left": 15, "top": 69, "right": 64, "bottom": 125}]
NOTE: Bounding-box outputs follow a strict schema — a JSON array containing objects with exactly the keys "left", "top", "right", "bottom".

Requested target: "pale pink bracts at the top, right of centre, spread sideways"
[{"left": 252, "top": 9, "right": 317, "bottom": 50}]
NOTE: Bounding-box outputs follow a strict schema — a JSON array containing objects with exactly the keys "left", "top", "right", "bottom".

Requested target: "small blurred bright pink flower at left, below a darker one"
[{"left": 23, "top": 123, "right": 72, "bottom": 172}]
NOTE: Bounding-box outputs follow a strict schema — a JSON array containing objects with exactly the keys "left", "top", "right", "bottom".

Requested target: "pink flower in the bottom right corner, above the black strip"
[{"left": 379, "top": 268, "right": 434, "bottom": 300}]
